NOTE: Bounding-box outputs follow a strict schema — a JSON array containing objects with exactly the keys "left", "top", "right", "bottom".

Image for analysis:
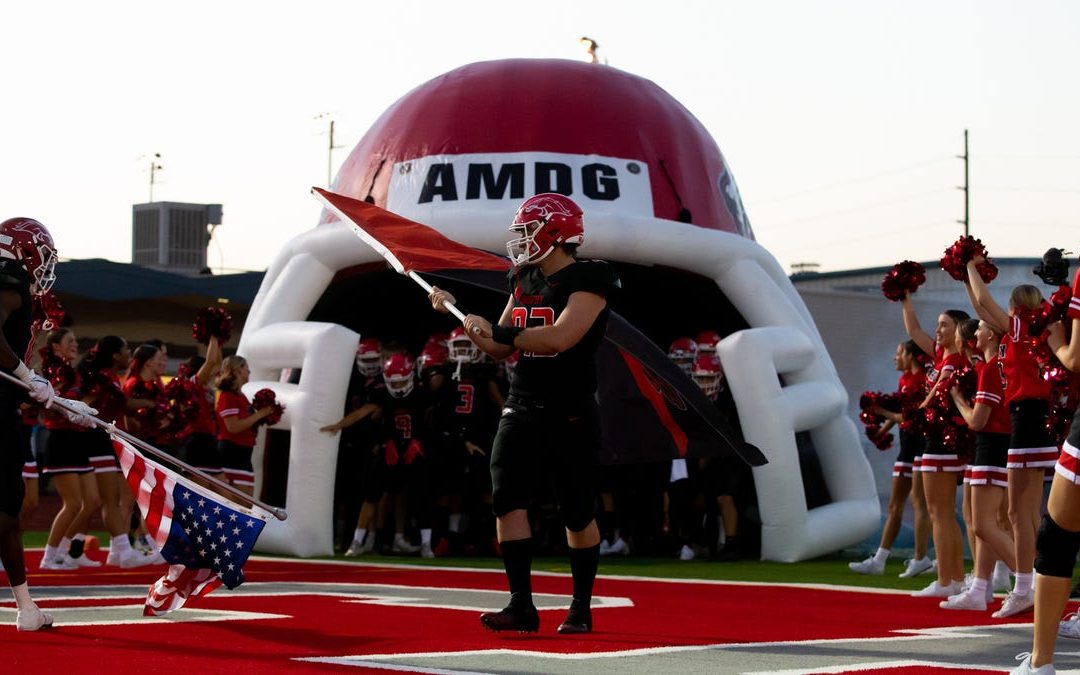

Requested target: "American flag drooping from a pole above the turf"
[{"left": 112, "top": 435, "right": 266, "bottom": 616}]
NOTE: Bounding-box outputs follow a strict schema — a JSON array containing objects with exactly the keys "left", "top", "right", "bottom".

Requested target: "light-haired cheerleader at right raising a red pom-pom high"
[{"left": 966, "top": 257, "right": 1058, "bottom": 619}]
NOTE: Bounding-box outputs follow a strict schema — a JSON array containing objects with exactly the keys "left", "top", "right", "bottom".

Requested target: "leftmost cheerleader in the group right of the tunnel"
[{"left": 848, "top": 340, "right": 933, "bottom": 579}]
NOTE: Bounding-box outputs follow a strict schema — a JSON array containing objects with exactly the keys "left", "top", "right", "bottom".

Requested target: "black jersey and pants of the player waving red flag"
[{"left": 491, "top": 260, "right": 619, "bottom": 531}]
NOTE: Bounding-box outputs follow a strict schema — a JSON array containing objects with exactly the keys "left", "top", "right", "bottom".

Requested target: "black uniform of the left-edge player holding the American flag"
[{"left": 0, "top": 258, "right": 33, "bottom": 518}]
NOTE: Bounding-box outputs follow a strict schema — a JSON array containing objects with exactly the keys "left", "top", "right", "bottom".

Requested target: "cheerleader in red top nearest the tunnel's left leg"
[{"left": 214, "top": 356, "right": 273, "bottom": 495}]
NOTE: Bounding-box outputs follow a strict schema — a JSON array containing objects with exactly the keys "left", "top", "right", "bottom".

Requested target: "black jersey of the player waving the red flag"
[{"left": 509, "top": 260, "right": 620, "bottom": 405}]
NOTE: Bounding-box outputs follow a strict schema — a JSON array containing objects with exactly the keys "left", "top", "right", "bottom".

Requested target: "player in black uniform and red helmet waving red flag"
[{"left": 430, "top": 193, "right": 619, "bottom": 633}]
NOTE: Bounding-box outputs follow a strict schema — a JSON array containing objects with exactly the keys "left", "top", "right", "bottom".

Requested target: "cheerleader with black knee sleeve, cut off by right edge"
[{"left": 1010, "top": 272, "right": 1080, "bottom": 675}]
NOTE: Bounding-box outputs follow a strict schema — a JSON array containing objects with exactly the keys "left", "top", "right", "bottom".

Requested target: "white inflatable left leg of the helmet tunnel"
[{"left": 242, "top": 322, "right": 359, "bottom": 556}]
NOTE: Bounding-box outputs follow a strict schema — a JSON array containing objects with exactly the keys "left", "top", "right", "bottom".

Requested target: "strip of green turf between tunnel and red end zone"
[{"left": 23, "top": 531, "right": 933, "bottom": 591}]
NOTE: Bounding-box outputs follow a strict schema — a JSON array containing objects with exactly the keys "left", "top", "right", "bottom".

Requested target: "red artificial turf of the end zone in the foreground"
[{"left": 0, "top": 553, "right": 1045, "bottom": 675}]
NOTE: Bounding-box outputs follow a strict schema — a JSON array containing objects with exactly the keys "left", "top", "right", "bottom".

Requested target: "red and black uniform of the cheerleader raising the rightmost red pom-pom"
[{"left": 998, "top": 315, "right": 1057, "bottom": 469}]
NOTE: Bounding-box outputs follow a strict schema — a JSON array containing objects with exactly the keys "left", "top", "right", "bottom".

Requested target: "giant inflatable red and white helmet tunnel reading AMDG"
[{"left": 239, "top": 59, "right": 879, "bottom": 561}]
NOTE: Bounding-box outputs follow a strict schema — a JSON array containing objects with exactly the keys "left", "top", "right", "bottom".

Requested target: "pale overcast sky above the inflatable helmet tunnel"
[{"left": 0, "top": 0, "right": 1080, "bottom": 270}]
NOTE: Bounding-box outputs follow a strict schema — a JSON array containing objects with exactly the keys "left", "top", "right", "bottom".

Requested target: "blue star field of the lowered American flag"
[{"left": 161, "top": 483, "right": 266, "bottom": 589}]
